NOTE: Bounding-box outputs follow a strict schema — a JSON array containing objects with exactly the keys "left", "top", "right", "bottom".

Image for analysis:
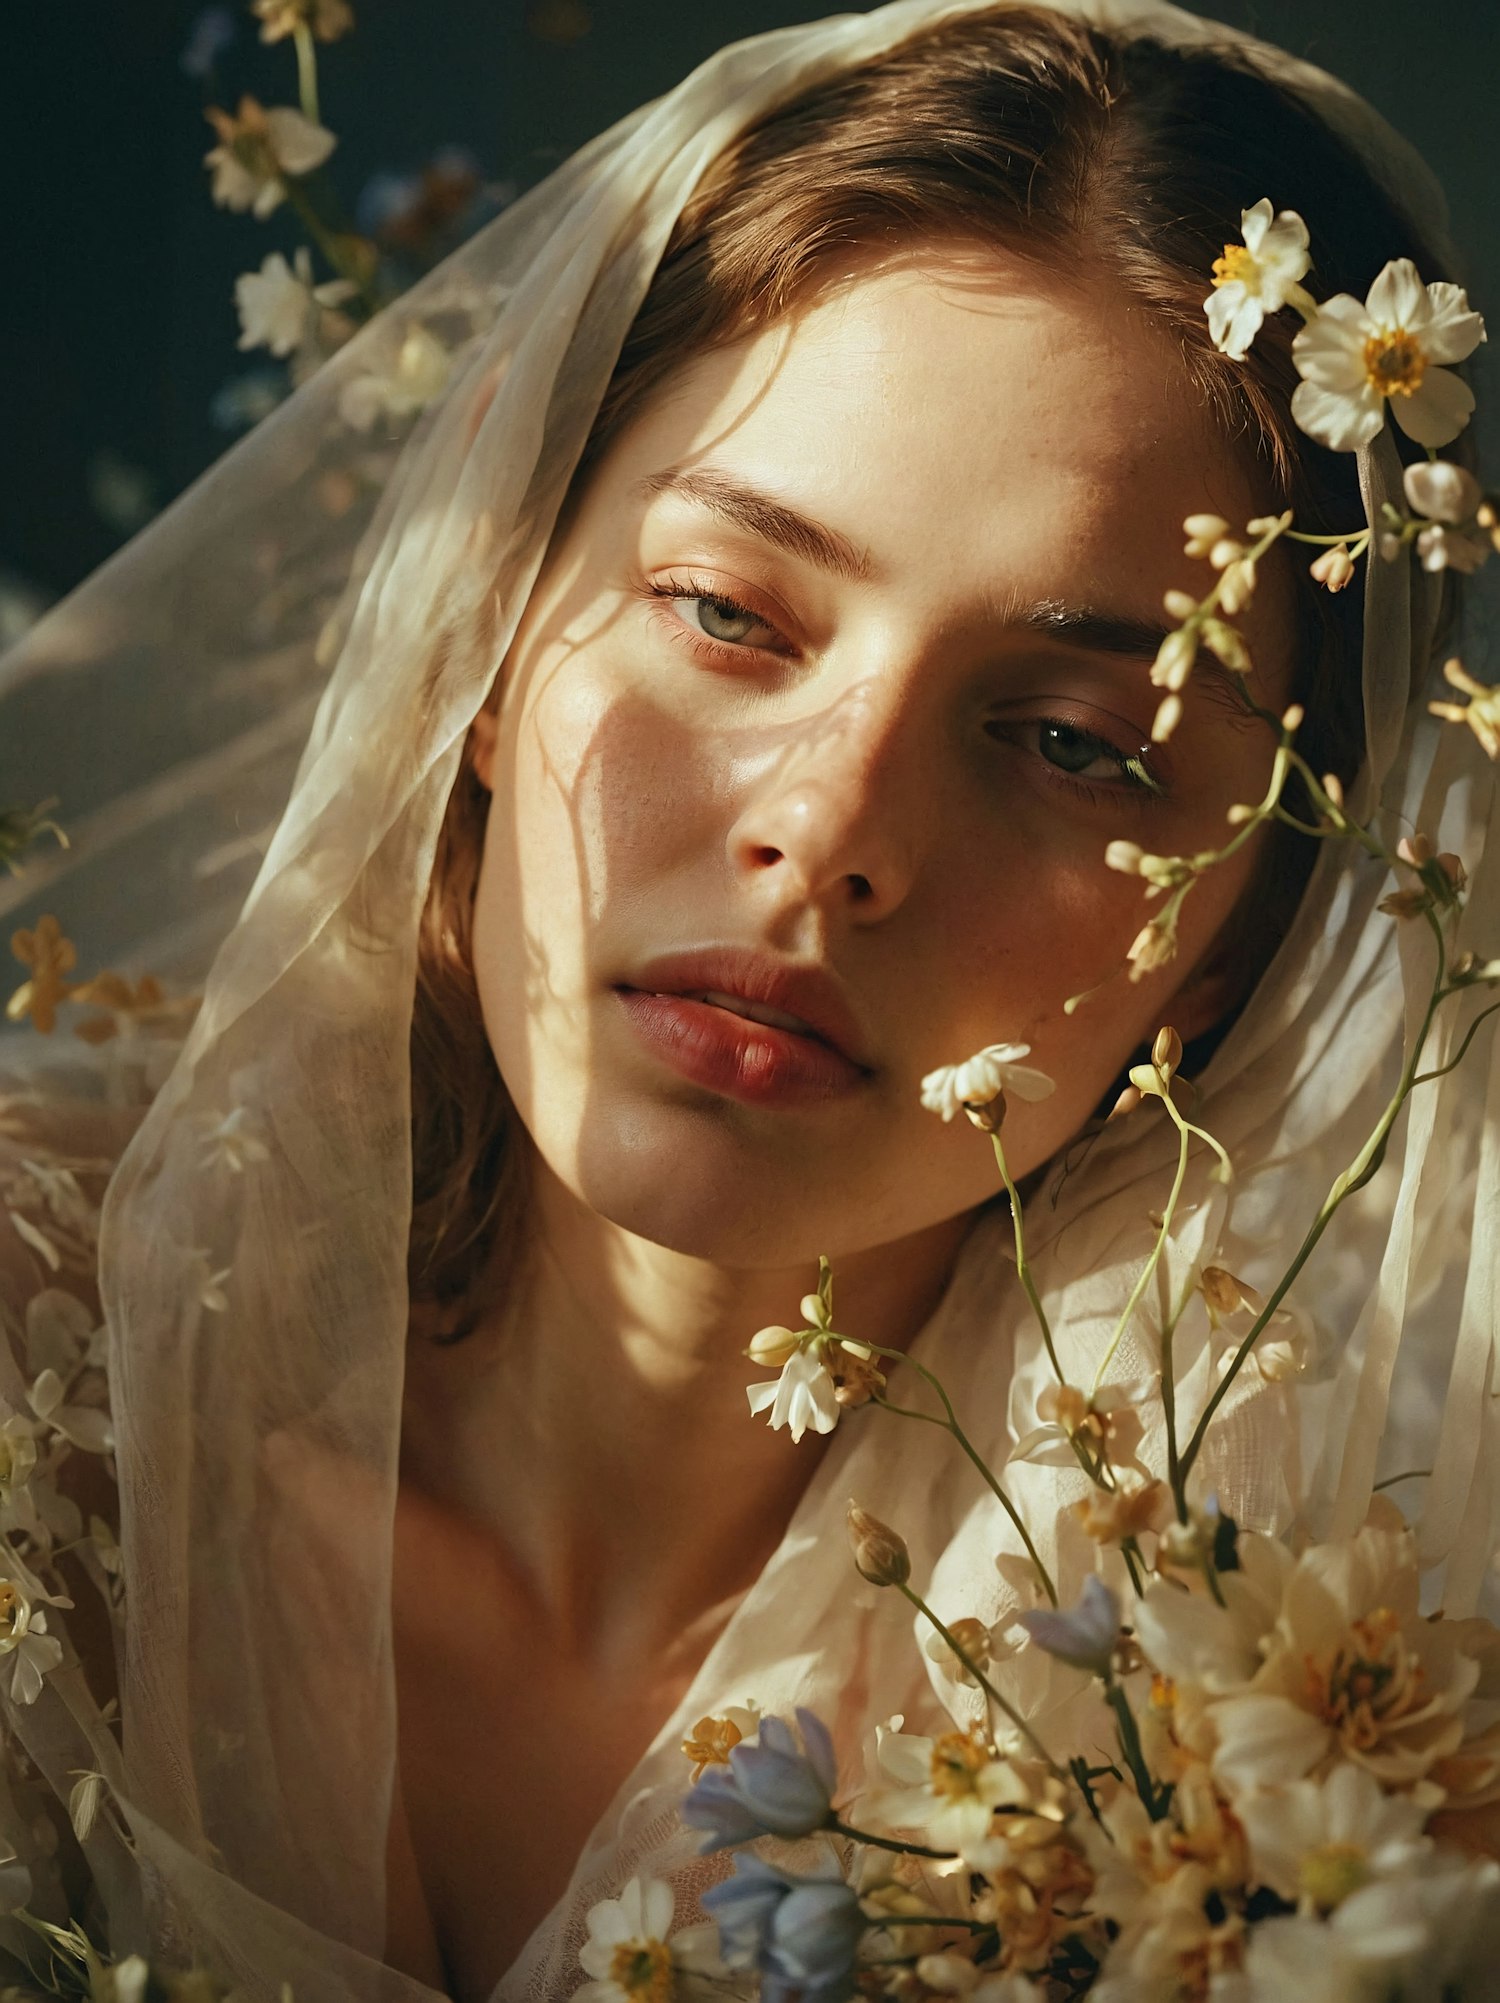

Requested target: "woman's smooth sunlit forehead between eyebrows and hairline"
[{"left": 605, "top": 262, "right": 1254, "bottom": 608}]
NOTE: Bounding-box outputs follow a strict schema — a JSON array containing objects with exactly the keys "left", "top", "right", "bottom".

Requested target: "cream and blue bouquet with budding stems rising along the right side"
[{"left": 585, "top": 202, "right": 1500, "bottom": 2003}]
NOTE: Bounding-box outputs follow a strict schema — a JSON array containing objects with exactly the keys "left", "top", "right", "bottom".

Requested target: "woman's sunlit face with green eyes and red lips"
[{"left": 475, "top": 252, "right": 1290, "bottom": 1266}]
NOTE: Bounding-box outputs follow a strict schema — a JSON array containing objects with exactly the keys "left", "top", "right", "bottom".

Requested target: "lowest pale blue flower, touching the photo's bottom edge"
[{"left": 703, "top": 1851, "right": 867, "bottom": 2003}]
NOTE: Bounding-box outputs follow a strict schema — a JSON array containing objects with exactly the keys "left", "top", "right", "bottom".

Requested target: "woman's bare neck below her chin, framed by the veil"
[{"left": 409, "top": 1170, "right": 969, "bottom": 1664}]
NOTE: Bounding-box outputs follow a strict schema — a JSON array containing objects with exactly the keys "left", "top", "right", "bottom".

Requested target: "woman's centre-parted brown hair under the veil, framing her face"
[{"left": 411, "top": 6, "right": 1457, "bottom": 1310}]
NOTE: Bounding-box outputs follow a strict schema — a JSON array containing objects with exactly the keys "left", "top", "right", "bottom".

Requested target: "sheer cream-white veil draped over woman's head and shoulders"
[{"left": 0, "top": 0, "right": 1500, "bottom": 2003}]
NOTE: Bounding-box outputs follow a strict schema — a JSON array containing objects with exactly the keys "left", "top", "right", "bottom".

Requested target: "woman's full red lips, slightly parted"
[{"left": 615, "top": 987, "right": 869, "bottom": 1106}]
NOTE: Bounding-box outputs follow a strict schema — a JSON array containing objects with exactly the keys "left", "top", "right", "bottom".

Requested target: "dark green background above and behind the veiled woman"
[{"left": 0, "top": 0, "right": 1500, "bottom": 593}]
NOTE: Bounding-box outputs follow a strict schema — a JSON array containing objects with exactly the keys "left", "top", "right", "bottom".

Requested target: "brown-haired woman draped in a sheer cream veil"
[{"left": 0, "top": 0, "right": 1494, "bottom": 1997}]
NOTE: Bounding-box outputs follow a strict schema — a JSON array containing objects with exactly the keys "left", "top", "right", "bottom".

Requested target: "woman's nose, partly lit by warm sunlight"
[{"left": 729, "top": 683, "right": 927, "bottom": 921}]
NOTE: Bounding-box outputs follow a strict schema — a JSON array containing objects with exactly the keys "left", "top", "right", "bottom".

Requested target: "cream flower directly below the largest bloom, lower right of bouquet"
[{"left": 1236, "top": 1765, "right": 1430, "bottom": 1913}]
